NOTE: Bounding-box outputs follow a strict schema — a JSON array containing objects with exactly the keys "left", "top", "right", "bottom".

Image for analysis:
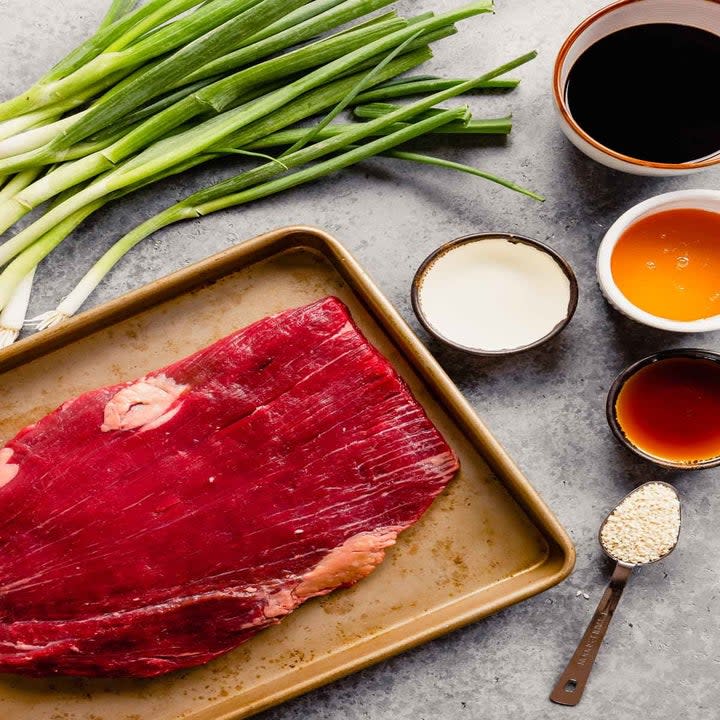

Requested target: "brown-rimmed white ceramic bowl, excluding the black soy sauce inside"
[{"left": 553, "top": 0, "right": 720, "bottom": 176}]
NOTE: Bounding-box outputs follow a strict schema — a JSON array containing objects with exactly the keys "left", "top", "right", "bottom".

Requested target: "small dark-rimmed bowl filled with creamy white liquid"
[{"left": 412, "top": 233, "right": 578, "bottom": 356}]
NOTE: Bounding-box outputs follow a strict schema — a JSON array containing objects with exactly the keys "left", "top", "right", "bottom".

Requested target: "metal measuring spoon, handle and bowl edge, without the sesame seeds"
[{"left": 550, "top": 481, "right": 682, "bottom": 705}]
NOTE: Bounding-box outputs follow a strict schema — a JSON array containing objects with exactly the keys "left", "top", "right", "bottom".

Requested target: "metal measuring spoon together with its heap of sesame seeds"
[{"left": 550, "top": 481, "right": 681, "bottom": 705}]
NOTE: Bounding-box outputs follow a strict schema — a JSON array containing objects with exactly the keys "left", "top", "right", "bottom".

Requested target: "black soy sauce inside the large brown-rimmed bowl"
[{"left": 566, "top": 23, "right": 720, "bottom": 163}]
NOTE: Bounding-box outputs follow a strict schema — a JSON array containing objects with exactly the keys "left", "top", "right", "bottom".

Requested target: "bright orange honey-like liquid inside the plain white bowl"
[{"left": 611, "top": 208, "right": 720, "bottom": 322}]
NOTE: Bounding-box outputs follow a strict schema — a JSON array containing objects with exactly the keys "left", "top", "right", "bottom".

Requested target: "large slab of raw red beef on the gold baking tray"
[{"left": 0, "top": 298, "right": 458, "bottom": 677}]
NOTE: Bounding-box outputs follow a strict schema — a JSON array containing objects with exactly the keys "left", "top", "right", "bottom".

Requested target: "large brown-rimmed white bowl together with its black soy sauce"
[{"left": 553, "top": 0, "right": 720, "bottom": 175}]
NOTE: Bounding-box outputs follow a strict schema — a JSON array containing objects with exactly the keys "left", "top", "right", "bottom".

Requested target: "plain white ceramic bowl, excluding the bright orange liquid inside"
[{"left": 597, "top": 190, "right": 720, "bottom": 333}]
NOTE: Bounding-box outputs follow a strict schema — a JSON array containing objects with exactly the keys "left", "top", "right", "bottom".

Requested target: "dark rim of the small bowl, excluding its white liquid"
[{"left": 411, "top": 233, "right": 579, "bottom": 357}]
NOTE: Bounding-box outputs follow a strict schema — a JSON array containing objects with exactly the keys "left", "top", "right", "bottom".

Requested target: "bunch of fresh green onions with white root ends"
[{"left": 0, "top": 0, "right": 542, "bottom": 347}]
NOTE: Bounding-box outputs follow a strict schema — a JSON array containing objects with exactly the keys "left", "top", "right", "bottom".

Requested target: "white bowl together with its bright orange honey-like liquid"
[{"left": 597, "top": 190, "right": 720, "bottom": 333}]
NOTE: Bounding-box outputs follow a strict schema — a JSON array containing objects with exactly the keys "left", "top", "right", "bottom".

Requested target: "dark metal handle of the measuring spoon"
[{"left": 550, "top": 563, "right": 632, "bottom": 705}]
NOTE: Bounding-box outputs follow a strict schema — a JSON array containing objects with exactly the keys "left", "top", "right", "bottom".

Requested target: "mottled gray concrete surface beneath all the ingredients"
[{"left": 0, "top": 0, "right": 720, "bottom": 720}]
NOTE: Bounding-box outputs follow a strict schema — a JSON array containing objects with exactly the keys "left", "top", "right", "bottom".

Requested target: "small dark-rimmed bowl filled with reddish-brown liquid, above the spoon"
[{"left": 607, "top": 350, "right": 720, "bottom": 470}]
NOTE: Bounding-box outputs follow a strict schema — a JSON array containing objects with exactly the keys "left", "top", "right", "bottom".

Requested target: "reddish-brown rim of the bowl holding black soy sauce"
[{"left": 553, "top": 0, "right": 720, "bottom": 172}]
